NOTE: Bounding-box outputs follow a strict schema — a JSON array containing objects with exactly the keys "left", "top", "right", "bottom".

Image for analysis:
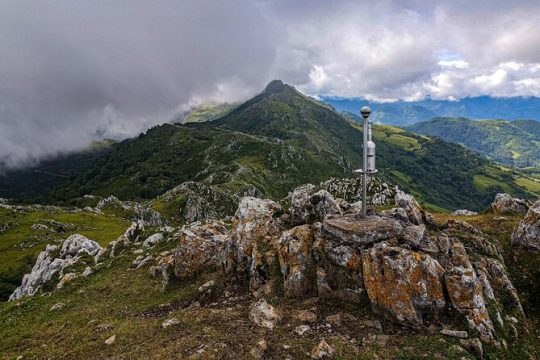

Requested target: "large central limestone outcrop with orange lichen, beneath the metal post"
[{"left": 170, "top": 185, "right": 522, "bottom": 343}]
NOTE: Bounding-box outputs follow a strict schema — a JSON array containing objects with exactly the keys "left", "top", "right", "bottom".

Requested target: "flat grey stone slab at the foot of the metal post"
[{"left": 322, "top": 214, "right": 403, "bottom": 248}]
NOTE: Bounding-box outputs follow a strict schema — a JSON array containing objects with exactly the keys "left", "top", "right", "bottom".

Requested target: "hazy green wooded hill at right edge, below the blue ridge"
[{"left": 407, "top": 118, "right": 540, "bottom": 168}]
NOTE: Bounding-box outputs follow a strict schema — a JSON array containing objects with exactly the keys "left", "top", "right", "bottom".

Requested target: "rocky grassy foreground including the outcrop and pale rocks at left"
[{"left": 0, "top": 186, "right": 540, "bottom": 359}]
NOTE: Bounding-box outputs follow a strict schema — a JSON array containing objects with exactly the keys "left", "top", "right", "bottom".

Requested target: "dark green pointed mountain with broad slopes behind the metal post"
[{"left": 0, "top": 81, "right": 537, "bottom": 210}]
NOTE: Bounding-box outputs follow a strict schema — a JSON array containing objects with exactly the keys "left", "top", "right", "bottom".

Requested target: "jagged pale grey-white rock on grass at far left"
[{"left": 9, "top": 234, "right": 104, "bottom": 301}]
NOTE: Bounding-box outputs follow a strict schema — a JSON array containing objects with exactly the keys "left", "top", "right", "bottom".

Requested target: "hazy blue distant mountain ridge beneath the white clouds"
[{"left": 322, "top": 96, "right": 540, "bottom": 126}]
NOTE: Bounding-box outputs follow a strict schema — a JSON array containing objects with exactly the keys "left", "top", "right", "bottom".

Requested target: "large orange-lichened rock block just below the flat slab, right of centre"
[{"left": 362, "top": 243, "right": 446, "bottom": 327}]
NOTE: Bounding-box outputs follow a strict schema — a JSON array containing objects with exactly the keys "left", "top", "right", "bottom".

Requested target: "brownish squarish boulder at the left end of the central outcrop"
[{"left": 174, "top": 222, "right": 229, "bottom": 279}]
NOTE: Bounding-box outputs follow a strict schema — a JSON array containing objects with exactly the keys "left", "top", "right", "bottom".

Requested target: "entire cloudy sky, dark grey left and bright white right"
[{"left": 0, "top": 0, "right": 540, "bottom": 167}]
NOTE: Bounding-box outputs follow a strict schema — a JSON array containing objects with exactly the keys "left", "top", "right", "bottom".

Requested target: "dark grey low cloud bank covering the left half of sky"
[{"left": 0, "top": 0, "right": 276, "bottom": 167}]
